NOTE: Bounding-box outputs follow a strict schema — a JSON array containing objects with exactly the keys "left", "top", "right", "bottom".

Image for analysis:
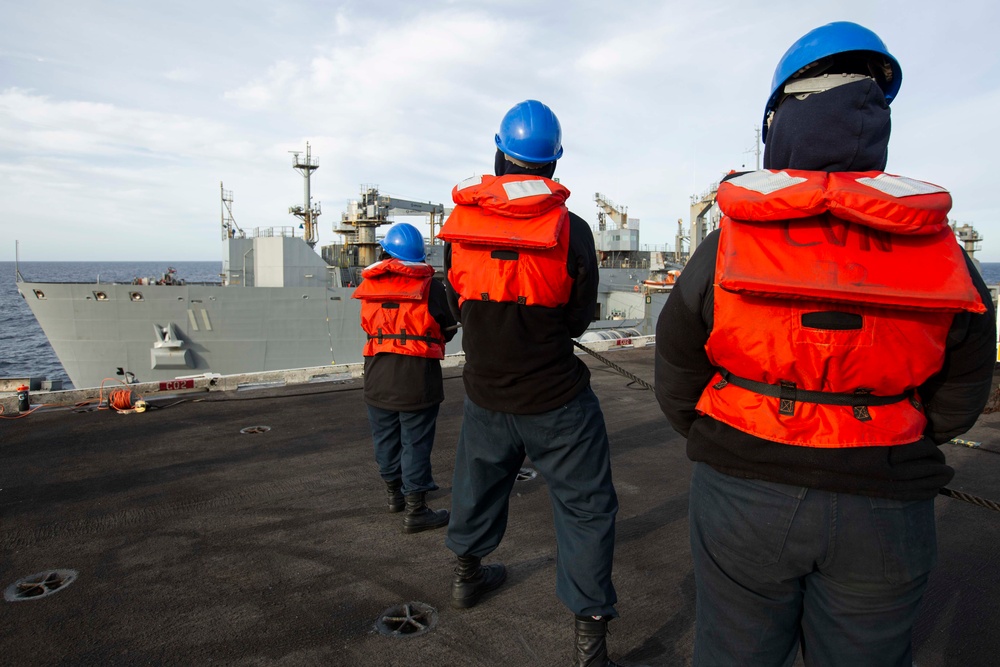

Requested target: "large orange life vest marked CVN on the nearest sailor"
[{"left": 697, "top": 170, "right": 986, "bottom": 448}]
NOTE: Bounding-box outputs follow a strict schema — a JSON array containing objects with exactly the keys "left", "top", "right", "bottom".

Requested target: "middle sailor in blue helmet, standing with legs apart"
[{"left": 439, "top": 100, "right": 618, "bottom": 667}]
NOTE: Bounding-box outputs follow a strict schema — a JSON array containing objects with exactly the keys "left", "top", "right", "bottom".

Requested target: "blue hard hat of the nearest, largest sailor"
[{"left": 761, "top": 21, "right": 903, "bottom": 141}]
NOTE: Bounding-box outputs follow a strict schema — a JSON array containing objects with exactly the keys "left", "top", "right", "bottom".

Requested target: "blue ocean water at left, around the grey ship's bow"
[{"left": 0, "top": 261, "right": 222, "bottom": 389}]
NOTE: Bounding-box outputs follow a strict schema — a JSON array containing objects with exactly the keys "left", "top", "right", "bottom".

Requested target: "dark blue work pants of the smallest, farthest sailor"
[{"left": 367, "top": 404, "right": 440, "bottom": 494}]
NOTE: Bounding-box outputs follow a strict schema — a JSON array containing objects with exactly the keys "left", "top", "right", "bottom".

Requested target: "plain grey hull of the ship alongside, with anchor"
[{"left": 18, "top": 282, "right": 378, "bottom": 387}]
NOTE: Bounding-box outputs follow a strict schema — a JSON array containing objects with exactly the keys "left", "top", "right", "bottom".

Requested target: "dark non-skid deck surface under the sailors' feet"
[{"left": 0, "top": 349, "right": 1000, "bottom": 667}]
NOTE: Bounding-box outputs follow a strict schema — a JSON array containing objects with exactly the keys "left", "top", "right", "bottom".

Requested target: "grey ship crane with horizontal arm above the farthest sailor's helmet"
[{"left": 334, "top": 185, "right": 444, "bottom": 266}]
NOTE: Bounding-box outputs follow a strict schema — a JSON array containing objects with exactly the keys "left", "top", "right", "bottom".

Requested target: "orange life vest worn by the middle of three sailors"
[{"left": 438, "top": 175, "right": 573, "bottom": 308}]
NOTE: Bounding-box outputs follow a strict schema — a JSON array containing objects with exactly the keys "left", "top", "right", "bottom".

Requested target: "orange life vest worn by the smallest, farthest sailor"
[{"left": 351, "top": 259, "right": 445, "bottom": 359}]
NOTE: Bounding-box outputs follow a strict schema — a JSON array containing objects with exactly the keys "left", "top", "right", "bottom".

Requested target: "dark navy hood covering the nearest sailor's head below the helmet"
[{"left": 764, "top": 80, "right": 890, "bottom": 171}]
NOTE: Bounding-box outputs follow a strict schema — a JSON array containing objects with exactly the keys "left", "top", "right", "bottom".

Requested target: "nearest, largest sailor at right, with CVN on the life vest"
[{"left": 656, "top": 22, "right": 996, "bottom": 667}]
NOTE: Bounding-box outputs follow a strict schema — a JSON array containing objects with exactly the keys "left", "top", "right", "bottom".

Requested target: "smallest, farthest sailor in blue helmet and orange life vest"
[{"left": 353, "top": 222, "right": 456, "bottom": 533}]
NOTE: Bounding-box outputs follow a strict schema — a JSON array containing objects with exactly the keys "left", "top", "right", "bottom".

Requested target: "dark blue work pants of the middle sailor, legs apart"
[{"left": 445, "top": 386, "right": 618, "bottom": 617}]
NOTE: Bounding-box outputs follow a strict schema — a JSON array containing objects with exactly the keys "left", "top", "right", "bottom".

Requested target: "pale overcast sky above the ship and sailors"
[{"left": 0, "top": 0, "right": 1000, "bottom": 262}]
